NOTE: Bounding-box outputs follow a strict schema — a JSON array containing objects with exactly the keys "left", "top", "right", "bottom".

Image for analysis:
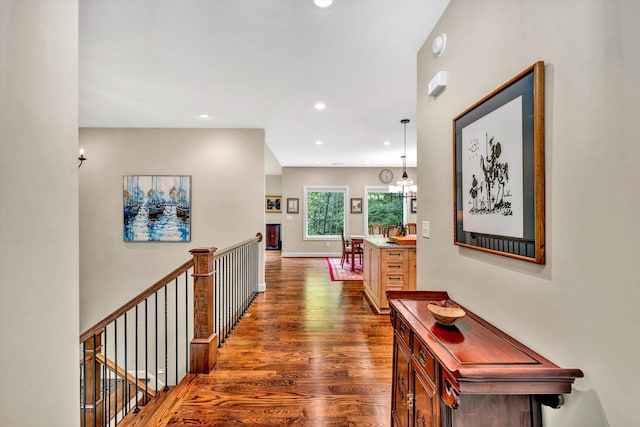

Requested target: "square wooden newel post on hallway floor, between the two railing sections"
[{"left": 189, "top": 248, "right": 218, "bottom": 374}]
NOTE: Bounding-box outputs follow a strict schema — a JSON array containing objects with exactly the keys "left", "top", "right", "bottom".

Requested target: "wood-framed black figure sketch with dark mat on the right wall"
[{"left": 453, "top": 61, "right": 545, "bottom": 264}]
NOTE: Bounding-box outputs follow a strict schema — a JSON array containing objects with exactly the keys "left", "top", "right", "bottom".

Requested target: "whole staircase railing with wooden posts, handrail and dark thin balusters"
[{"left": 80, "top": 233, "right": 262, "bottom": 427}]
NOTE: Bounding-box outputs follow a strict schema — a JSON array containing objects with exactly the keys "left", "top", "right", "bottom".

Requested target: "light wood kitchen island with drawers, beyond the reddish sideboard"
[{"left": 363, "top": 237, "right": 416, "bottom": 314}]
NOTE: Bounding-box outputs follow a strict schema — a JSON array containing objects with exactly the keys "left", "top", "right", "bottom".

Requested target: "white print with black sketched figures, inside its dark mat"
[{"left": 462, "top": 96, "right": 523, "bottom": 238}]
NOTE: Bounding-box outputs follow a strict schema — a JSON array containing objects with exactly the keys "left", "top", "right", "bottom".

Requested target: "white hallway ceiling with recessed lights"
[{"left": 79, "top": 0, "right": 448, "bottom": 167}]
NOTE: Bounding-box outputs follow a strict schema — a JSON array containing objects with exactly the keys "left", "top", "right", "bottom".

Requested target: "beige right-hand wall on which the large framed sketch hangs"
[{"left": 418, "top": 0, "right": 640, "bottom": 427}]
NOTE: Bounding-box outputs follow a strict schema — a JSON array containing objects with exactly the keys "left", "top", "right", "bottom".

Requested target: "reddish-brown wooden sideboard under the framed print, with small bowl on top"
[{"left": 387, "top": 291, "right": 583, "bottom": 427}]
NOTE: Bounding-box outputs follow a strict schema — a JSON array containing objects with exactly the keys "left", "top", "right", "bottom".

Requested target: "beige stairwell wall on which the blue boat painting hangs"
[{"left": 80, "top": 128, "right": 265, "bottom": 330}]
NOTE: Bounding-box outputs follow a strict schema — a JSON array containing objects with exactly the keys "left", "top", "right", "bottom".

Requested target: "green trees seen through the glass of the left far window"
[{"left": 307, "top": 191, "right": 345, "bottom": 236}]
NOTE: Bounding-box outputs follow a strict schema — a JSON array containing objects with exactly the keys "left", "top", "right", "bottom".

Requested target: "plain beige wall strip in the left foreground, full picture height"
[{"left": 0, "top": 0, "right": 80, "bottom": 427}]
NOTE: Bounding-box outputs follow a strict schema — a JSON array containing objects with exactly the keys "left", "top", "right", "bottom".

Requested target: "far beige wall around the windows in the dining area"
[{"left": 282, "top": 167, "right": 420, "bottom": 256}]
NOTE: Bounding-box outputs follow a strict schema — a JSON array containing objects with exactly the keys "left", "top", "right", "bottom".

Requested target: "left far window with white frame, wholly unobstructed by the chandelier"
[{"left": 304, "top": 185, "right": 347, "bottom": 240}]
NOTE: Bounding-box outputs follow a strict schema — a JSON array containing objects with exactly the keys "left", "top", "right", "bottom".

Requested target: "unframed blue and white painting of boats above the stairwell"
[{"left": 122, "top": 175, "right": 191, "bottom": 242}]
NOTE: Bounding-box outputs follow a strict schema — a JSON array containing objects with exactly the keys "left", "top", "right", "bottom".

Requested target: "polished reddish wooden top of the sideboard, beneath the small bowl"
[{"left": 387, "top": 291, "right": 583, "bottom": 394}]
